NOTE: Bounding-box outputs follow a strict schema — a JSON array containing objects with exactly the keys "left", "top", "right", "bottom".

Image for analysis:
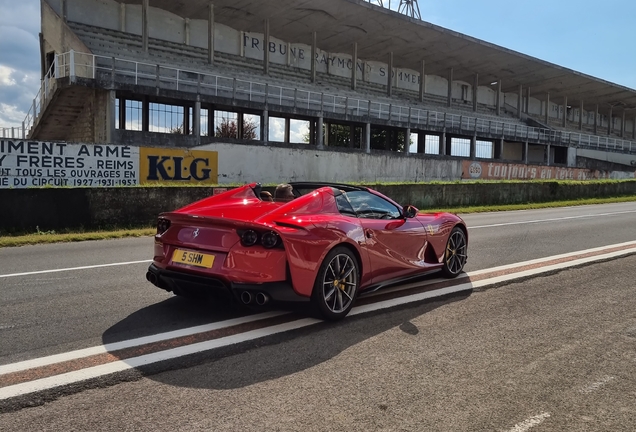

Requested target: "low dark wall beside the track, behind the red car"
[{"left": 0, "top": 180, "right": 636, "bottom": 234}]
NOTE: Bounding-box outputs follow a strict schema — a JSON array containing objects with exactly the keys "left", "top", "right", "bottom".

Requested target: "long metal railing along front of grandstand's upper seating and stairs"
[{"left": 24, "top": 51, "right": 636, "bottom": 153}]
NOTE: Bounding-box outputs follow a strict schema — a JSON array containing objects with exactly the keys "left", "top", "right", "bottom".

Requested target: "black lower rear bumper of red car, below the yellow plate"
[{"left": 146, "top": 264, "right": 309, "bottom": 302}]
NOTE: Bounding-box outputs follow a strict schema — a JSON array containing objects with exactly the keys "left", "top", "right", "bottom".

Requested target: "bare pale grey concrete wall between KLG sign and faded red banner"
[{"left": 197, "top": 143, "right": 462, "bottom": 183}]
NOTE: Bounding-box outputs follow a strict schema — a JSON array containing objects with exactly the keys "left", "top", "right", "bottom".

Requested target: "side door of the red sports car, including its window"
[{"left": 347, "top": 191, "right": 427, "bottom": 283}]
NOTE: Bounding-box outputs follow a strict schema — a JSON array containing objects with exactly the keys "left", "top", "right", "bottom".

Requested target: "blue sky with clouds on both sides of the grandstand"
[{"left": 0, "top": 0, "right": 636, "bottom": 131}]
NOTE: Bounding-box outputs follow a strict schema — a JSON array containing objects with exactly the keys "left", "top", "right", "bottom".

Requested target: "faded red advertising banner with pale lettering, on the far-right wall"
[{"left": 462, "top": 161, "right": 634, "bottom": 180}]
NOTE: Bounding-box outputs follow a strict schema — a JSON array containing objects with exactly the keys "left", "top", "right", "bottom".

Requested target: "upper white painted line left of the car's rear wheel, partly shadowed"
[{"left": 0, "top": 311, "right": 286, "bottom": 375}]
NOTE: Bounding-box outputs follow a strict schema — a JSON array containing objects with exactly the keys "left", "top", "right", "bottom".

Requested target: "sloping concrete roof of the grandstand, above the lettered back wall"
[{"left": 123, "top": 0, "right": 636, "bottom": 114}]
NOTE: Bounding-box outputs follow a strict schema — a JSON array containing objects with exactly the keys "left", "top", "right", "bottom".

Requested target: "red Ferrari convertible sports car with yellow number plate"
[{"left": 146, "top": 183, "right": 468, "bottom": 320}]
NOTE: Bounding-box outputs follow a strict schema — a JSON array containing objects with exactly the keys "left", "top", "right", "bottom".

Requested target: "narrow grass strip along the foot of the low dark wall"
[{"left": 0, "top": 196, "right": 636, "bottom": 248}]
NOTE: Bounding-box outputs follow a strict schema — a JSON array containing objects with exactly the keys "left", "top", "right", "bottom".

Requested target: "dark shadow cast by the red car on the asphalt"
[{"left": 98, "top": 291, "right": 472, "bottom": 390}]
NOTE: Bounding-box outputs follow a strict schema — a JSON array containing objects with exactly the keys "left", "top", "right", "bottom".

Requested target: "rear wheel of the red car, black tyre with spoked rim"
[{"left": 311, "top": 246, "right": 360, "bottom": 321}]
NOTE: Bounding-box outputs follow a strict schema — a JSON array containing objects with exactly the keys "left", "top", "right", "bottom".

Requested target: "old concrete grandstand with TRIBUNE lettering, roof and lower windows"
[{"left": 8, "top": 0, "right": 636, "bottom": 176}]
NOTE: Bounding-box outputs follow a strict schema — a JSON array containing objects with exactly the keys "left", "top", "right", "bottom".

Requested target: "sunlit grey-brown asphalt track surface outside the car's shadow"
[{"left": 0, "top": 203, "right": 636, "bottom": 430}]
